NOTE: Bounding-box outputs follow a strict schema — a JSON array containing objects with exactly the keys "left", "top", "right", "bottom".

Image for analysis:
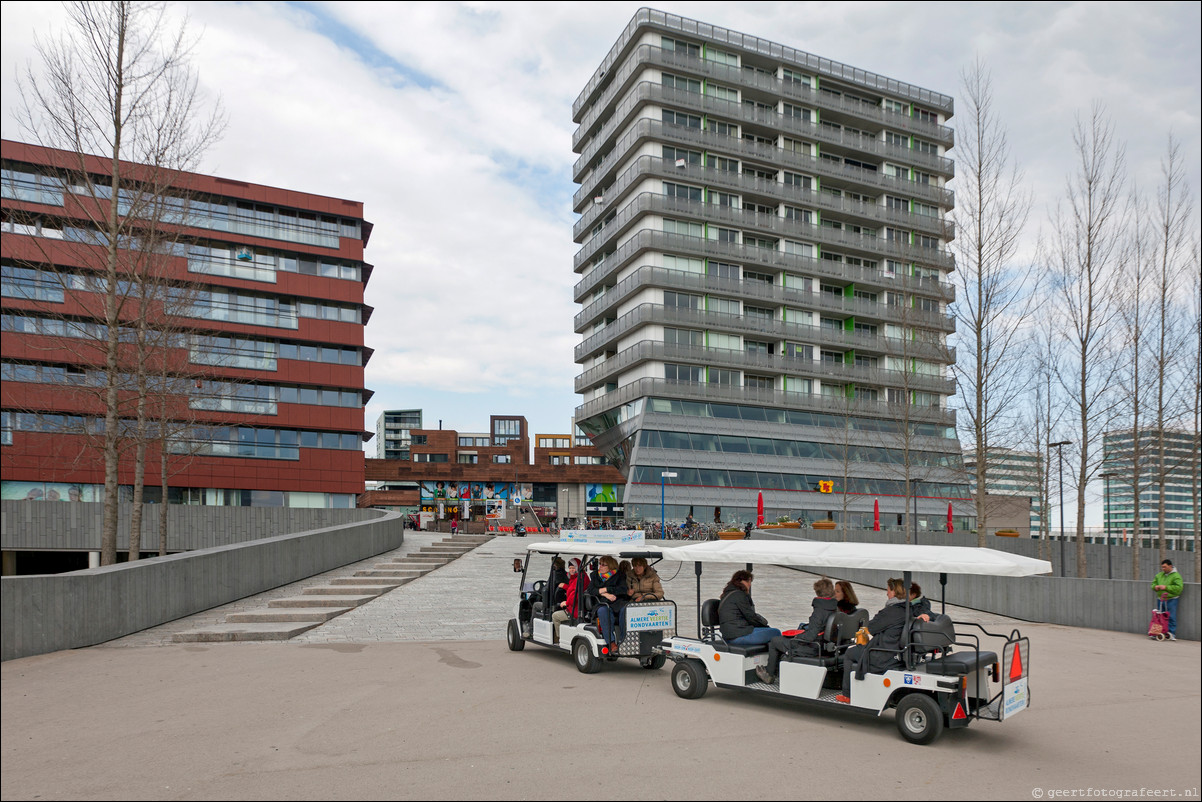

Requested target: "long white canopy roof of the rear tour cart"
[{"left": 664, "top": 540, "right": 1052, "bottom": 576}]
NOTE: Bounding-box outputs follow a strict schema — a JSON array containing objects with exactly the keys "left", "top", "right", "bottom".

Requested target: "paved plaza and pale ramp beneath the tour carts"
[{"left": 0, "top": 533, "right": 1202, "bottom": 800}]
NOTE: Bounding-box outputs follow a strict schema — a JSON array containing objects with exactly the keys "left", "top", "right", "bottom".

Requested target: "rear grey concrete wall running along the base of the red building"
[{"left": 0, "top": 500, "right": 376, "bottom": 552}]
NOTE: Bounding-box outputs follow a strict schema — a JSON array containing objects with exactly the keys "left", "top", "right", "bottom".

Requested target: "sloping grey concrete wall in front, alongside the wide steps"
[{"left": 0, "top": 510, "right": 404, "bottom": 660}]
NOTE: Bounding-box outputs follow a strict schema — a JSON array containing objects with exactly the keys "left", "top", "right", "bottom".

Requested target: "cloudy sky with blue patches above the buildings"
[{"left": 0, "top": 2, "right": 1202, "bottom": 461}]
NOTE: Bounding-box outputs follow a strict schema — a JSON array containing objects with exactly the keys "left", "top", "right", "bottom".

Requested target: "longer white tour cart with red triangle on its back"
[{"left": 661, "top": 540, "right": 1052, "bottom": 744}]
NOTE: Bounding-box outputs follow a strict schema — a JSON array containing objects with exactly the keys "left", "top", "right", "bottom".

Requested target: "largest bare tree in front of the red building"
[{"left": 19, "top": 1, "right": 222, "bottom": 565}]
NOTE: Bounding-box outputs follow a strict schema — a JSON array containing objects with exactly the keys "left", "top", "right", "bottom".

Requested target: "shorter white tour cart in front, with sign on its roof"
[{"left": 506, "top": 529, "right": 677, "bottom": 673}]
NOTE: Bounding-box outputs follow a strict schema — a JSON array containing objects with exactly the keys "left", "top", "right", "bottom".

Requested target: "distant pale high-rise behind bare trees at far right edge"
[{"left": 1102, "top": 428, "right": 1200, "bottom": 548}]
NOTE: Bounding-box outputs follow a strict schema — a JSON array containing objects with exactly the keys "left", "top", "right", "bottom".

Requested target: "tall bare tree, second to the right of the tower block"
[{"left": 1047, "top": 103, "right": 1125, "bottom": 577}]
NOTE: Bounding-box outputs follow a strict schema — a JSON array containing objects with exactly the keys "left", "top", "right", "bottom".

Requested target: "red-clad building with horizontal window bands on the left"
[{"left": 0, "top": 141, "right": 371, "bottom": 509}]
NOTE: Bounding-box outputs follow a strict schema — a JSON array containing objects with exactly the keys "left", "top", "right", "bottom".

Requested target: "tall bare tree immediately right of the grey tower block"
[{"left": 953, "top": 60, "right": 1037, "bottom": 546}]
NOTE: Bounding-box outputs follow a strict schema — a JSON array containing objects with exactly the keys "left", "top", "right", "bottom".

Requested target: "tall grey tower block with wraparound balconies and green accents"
[{"left": 572, "top": 8, "right": 968, "bottom": 527}]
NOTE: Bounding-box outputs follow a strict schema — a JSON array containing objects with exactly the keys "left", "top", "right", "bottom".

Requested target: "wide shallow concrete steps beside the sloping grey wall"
[{"left": 174, "top": 535, "right": 493, "bottom": 643}]
